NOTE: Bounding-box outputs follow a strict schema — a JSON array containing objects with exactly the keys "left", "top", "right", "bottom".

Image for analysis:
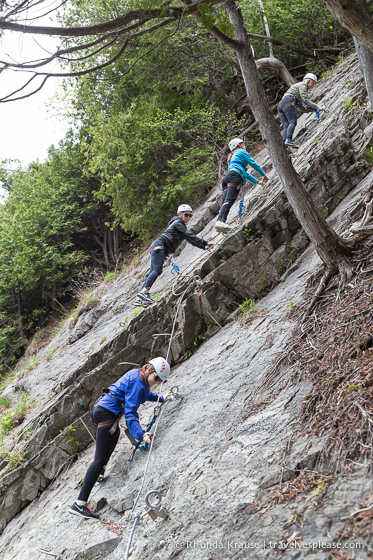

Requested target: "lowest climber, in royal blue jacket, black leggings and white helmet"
[{"left": 69, "top": 358, "right": 171, "bottom": 519}]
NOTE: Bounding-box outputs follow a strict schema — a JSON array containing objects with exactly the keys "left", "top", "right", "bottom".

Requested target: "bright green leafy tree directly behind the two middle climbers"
[{"left": 87, "top": 103, "right": 235, "bottom": 238}]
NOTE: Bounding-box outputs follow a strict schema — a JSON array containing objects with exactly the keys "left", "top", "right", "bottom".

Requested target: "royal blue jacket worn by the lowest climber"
[{"left": 97, "top": 369, "right": 163, "bottom": 440}]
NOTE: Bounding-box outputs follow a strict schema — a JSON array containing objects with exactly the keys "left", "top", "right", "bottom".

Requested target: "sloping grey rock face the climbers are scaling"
[{"left": 0, "top": 53, "right": 373, "bottom": 560}]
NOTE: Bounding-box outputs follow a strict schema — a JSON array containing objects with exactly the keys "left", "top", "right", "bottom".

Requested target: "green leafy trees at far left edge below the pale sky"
[{"left": 0, "top": 137, "right": 103, "bottom": 371}]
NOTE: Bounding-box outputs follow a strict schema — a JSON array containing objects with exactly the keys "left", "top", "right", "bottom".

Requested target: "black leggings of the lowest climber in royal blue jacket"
[{"left": 78, "top": 405, "right": 120, "bottom": 502}]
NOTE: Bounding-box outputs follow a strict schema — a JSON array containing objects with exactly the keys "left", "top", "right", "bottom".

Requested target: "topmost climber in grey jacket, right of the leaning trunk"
[{"left": 278, "top": 74, "right": 326, "bottom": 148}]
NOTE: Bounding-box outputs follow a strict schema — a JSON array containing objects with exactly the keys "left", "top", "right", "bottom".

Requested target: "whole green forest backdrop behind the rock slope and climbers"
[{"left": 0, "top": 0, "right": 353, "bottom": 374}]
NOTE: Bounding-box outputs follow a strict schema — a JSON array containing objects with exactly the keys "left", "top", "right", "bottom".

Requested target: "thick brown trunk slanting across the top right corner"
[{"left": 325, "top": 0, "right": 373, "bottom": 51}]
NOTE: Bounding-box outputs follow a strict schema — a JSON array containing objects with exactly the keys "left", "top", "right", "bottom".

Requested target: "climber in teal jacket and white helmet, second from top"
[{"left": 215, "top": 138, "right": 268, "bottom": 233}]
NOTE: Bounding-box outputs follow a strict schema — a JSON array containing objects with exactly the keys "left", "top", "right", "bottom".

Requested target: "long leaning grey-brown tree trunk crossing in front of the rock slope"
[{"left": 226, "top": 1, "right": 352, "bottom": 281}]
